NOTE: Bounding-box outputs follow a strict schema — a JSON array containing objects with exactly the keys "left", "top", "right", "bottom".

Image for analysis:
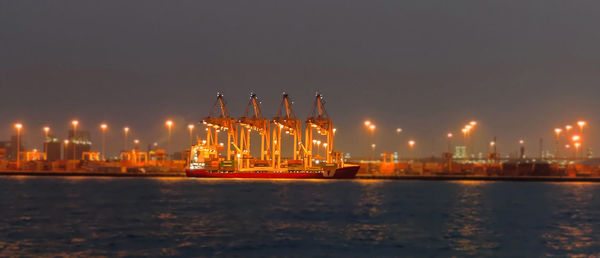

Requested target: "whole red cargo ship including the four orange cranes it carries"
[{"left": 186, "top": 93, "right": 360, "bottom": 179}]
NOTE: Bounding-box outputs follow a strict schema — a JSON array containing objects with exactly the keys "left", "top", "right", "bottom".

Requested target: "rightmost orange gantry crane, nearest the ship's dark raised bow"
[{"left": 304, "top": 92, "right": 333, "bottom": 167}]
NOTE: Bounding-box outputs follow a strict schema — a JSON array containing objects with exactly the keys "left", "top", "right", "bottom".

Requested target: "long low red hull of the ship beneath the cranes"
[{"left": 185, "top": 166, "right": 360, "bottom": 179}]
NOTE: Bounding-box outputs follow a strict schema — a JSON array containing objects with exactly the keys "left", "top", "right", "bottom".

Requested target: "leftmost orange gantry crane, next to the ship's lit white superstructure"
[{"left": 202, "top": 93, "right": 239, "bottom": 160}]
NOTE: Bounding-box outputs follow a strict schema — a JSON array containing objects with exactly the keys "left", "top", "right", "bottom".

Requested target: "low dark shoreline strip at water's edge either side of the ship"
[{"left": 0, "top": 171, "right": 600, "bottom": 182}]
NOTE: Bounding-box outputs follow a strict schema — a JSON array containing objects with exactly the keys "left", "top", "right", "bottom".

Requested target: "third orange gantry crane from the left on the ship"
[{"left": 272, "top": 92, "right": 302, "bottom": 169}]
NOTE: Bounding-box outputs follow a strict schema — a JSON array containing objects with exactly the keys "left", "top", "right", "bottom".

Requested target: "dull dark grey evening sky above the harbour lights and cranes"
[{"left": 0, "top": 0, "right": 600, "bottom": 155}]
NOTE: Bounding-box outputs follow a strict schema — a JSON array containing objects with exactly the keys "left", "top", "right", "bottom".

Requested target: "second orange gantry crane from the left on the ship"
[{"left": 238, "top": 93, "right": 271, "bottom": 167}]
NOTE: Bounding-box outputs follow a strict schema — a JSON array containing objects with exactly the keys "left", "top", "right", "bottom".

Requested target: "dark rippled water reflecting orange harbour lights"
[{"left": 0, "top": 177, "right": 600, "bottom": 257}]
